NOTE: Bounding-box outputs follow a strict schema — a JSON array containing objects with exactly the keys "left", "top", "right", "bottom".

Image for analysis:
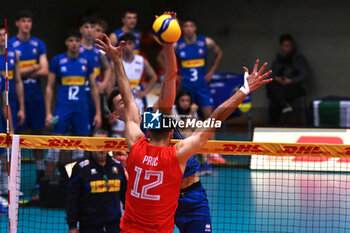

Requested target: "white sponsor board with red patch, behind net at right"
[{"left": 250, "top": 128, "right": 350, "bottom": 171}]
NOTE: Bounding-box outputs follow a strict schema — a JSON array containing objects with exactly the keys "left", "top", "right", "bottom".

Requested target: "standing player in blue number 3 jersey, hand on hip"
[{"left": 175, "top": 17, "right": 225, "bottom": 172}]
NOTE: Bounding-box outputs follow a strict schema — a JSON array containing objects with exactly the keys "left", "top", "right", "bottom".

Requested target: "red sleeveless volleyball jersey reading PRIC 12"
[{"left": 120, "top": 137, "right": 183, "bottom": 233}]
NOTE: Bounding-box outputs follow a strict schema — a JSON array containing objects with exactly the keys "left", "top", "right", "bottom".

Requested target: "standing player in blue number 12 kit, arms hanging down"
[{"left": 45, "top": 31, "right": 101, "bottom": 175}]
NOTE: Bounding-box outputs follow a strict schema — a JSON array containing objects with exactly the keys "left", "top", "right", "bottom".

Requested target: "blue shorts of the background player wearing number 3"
[{"left": 182, "top": 79, "right": 213, "bottom": 107}]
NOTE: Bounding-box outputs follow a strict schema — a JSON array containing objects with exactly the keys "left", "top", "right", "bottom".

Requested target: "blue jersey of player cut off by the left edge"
[{"left": 0, "top": 48, "right": 17, "bottom": 103}]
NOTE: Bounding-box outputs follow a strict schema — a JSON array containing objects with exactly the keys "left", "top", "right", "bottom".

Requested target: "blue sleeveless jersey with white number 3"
[{"left": 176, "top": 36, "right": 207, "bottom": 84}]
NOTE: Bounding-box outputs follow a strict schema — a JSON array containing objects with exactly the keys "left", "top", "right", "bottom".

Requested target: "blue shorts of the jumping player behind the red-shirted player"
[{"left": 175, "top": 186, "right": 212, "bottom": 233}]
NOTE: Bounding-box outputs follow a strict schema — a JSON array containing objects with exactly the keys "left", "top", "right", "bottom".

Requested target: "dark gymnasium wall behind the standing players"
[{"left": 0, "top": 0, "right": 350, "bottom": 123}]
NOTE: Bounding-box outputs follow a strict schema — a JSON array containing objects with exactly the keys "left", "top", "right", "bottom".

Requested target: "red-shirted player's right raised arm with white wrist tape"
[{"left": 175, "top": 60, "right": 272, "bottom": 169}]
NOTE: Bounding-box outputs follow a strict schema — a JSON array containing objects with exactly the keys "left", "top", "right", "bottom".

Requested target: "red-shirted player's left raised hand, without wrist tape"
[{"left": 95, "top": 34, "right": 125, "bottom": 62}]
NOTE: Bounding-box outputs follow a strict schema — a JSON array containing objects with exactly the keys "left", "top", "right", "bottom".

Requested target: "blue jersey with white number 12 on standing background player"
[{"left": 50, "top": 53, "right": 93, "bottom": 106}]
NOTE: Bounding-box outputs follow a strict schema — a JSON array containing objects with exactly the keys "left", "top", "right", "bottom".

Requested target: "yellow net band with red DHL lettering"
[{"left": 0, "top": 134, "right": 350, "bottom": 158}]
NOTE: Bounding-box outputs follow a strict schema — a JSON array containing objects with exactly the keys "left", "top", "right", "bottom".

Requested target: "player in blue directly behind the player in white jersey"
[{"left": 109, "top": 10, "right": 141, "bottom": 54}]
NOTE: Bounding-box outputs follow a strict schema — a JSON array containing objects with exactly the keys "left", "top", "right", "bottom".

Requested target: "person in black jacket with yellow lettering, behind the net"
[{"left": 66, "top": 129, "right": 127, "bottom": 233}]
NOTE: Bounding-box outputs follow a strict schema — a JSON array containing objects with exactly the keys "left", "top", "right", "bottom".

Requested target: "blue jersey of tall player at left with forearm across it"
[{"left": 9, "top": 36, "right": 46, "bottom": 101}]
